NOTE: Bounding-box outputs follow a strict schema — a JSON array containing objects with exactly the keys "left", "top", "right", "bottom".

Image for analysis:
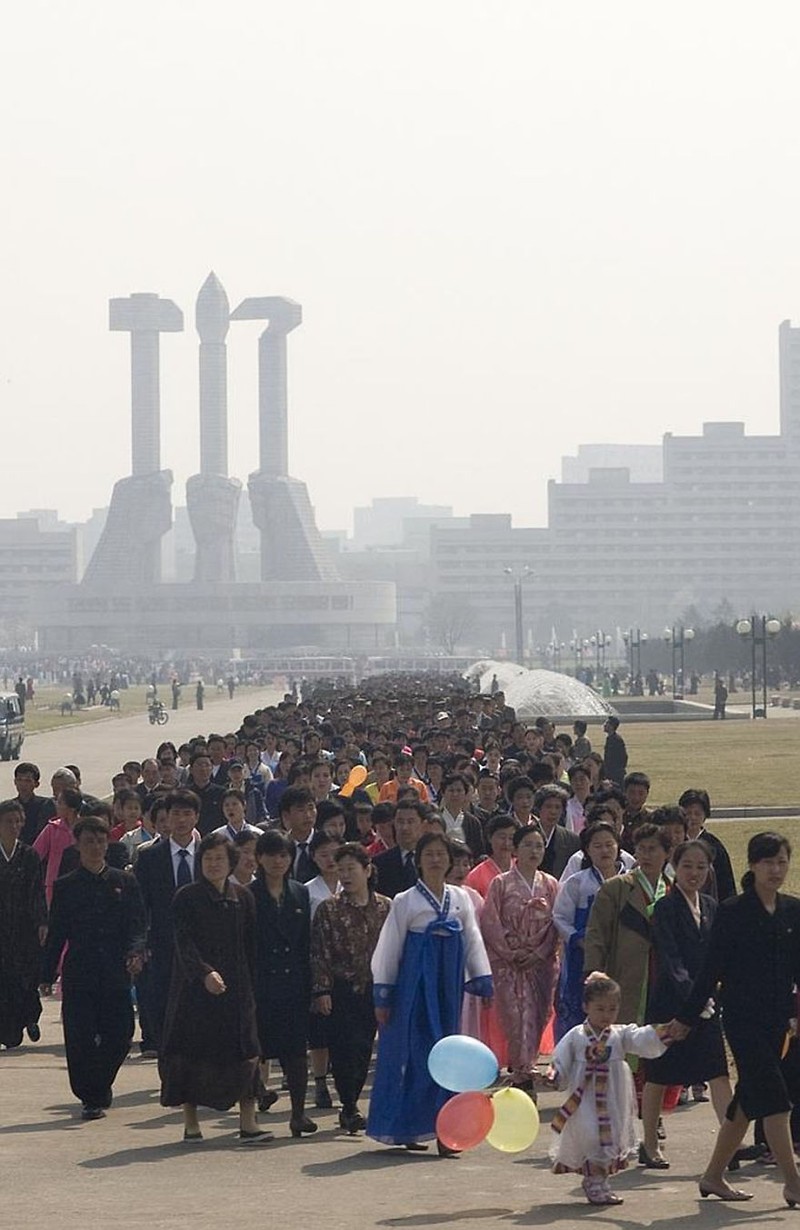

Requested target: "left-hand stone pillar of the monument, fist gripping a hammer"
[{"left": 82, "top": 294, "right": 183, "bottom": 589}]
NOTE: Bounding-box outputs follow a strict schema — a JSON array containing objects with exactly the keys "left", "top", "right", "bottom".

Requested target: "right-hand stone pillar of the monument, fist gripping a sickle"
[{"left": 230, "top": 296, "right": 338, "bottom": 581}]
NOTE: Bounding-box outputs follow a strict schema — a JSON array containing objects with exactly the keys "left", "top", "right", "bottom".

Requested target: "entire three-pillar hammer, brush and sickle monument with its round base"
[{"left": 43, "top": 273, "right": 396, "bottom": 662}]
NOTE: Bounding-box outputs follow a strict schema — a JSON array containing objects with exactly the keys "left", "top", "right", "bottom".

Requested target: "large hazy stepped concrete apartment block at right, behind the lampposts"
[{"left": 548, "top": 423, "right": 800, "bottom": 632}]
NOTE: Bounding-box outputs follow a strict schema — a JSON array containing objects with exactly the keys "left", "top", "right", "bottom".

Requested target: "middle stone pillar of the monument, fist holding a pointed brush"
[{"left": 186, "top": 273, "right": 241, "bottom": 583}]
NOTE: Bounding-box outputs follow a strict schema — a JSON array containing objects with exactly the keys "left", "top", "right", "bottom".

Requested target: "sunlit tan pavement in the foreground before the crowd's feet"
[{"left": 6, "top": 1001, "right": 800, "bottom": 1230}]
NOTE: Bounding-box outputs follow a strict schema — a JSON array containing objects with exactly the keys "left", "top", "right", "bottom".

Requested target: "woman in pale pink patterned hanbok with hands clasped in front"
[{"left": 480, "top": 825, "right": 559, "bottom": 1093}]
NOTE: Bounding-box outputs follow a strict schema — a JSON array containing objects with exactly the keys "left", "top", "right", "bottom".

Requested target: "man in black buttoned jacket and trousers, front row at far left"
[{"left": 39, "top": 815, "right": 145, "bottom": 1119}]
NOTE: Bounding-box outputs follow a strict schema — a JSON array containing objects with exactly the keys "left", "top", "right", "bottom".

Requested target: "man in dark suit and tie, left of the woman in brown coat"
[{"left": 134, "top": 790, "right": 201, "bottom": 1059}]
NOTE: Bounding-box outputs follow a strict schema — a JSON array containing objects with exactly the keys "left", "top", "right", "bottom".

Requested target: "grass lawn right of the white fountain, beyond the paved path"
[{"left": 620, "top": 715, "right": 800, "bottom": 807}]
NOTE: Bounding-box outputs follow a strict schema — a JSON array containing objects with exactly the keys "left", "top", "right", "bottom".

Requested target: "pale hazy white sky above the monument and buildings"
[{"left": 0, "top": 0, "right": 800, "bottom": 529}]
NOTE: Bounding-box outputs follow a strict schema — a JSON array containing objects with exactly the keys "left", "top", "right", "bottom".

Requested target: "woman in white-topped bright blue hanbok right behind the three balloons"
[{"left": 367, "top": 833, "right": 492, "bottom": 1151}]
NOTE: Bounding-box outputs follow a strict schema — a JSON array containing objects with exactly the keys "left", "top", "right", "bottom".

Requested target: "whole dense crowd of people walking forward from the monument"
[{"left": 0, "top": 679, "right": 800, "bottom": 1204}]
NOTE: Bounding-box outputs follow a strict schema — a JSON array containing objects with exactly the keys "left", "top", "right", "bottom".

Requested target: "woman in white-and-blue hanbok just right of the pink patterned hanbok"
[{"left": 553, "top": 820, "right": 622, "bottom": 1042}]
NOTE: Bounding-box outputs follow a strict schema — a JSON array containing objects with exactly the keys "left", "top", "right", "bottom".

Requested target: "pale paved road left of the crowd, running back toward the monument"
[{"left": 0, "top": 688, "right": 283, "bottom": 798}]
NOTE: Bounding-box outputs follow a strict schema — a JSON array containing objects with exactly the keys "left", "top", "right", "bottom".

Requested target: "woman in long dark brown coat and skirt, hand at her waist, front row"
[{"left": 159, "top": 834, "right": 272, "bottom": 1144}]
